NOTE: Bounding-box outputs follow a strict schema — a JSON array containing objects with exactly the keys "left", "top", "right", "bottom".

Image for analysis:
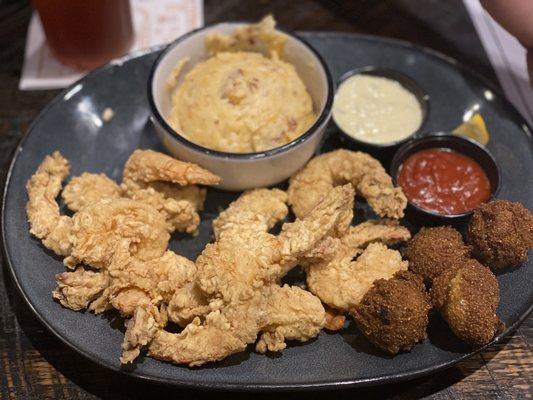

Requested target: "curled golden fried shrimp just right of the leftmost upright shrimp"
[{"left": 66, "top": 199, "right": 170, "bottom": 268}]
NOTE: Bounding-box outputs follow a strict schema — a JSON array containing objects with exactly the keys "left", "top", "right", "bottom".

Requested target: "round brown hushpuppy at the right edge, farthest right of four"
[{"left": 467, "top": 200, "right": 533, "bottom": 269}]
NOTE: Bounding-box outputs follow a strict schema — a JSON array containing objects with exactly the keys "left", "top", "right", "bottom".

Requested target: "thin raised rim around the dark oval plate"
[{"left": 4, "top": 31, "right": 533, "bottom": 392}]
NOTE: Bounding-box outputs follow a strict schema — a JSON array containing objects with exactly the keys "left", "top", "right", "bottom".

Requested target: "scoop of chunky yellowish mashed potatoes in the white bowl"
[{"left": 169, "top": 16, "right": 315, "bottom": 153}]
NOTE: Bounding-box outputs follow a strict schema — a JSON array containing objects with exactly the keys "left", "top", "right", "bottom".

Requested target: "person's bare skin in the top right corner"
[{"left": 480, "top": 0, "right": 533, "bottom": 83}]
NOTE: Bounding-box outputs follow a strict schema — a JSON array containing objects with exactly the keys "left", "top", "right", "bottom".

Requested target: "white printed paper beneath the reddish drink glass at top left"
[{"left": 19, "top": 0, "right": 204, "bottom": 90}]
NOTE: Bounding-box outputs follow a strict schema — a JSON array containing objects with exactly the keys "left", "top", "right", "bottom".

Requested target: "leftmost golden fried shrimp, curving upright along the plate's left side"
[{"left": 26, "top": 151, "right": 72, "bottom": 256}]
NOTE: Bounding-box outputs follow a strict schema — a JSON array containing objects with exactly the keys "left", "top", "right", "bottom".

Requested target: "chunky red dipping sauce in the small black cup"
[{"left": 397, "top": 148, "right": 491, "bottom": 215}]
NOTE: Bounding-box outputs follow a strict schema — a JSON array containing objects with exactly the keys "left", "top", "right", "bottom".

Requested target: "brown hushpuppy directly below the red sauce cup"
[{"left": 403, "top": 226, "right": 470, "bottom": 284}]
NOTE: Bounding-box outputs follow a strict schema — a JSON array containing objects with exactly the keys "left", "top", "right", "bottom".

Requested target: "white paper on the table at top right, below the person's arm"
[{"left": 463, "top": 0, "right": 533, "bottom": 125}]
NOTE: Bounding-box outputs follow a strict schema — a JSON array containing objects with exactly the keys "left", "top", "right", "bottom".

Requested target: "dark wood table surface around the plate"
[{"left": 0, "top": 0, "right": 533, "bottom": 400}]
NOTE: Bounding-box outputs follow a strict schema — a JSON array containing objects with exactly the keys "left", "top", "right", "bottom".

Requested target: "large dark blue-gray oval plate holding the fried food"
[{"left": 2, "top": 33, "right": 533, "bottom": 390}]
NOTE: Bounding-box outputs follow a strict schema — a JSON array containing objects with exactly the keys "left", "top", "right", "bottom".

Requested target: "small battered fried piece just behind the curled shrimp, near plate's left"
[{"left": 61, "top": 172, "right": 122, "bottom": 211}]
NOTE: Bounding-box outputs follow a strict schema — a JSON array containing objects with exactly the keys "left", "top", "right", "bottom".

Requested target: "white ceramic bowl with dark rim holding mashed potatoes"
[{"left": 148, "top": 23, "right": 334, "bottom": 190}]
